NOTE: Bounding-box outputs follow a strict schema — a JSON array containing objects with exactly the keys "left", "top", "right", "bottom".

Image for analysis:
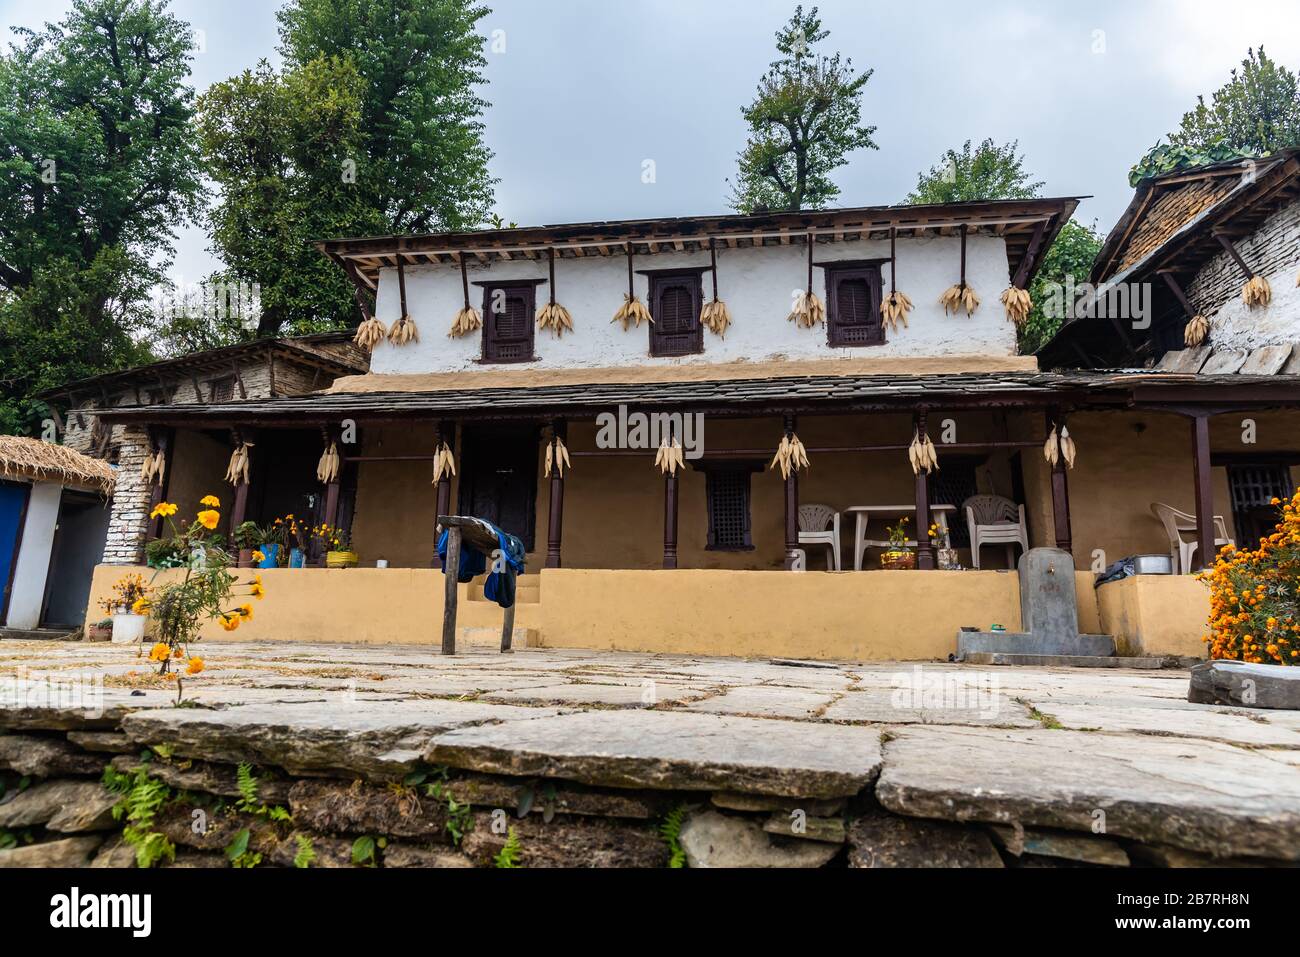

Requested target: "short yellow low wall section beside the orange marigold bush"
[{"left": 1096, "top": 575, "right": 1210, "bottom": 658}]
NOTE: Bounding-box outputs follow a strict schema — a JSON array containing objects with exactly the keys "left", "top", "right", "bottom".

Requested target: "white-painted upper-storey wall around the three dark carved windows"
[{"left": 371, "top": 235, "right": 1015, "bottom": 374}]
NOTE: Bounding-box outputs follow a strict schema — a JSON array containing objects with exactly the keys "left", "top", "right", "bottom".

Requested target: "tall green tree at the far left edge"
[{"left": 0, "top": 0, "right": 202, "bottom": 430}]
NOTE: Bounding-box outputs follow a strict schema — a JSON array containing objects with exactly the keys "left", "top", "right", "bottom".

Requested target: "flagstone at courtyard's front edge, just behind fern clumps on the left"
[{"left": 122, "top": 701, "right": 558, "bottom": 780}]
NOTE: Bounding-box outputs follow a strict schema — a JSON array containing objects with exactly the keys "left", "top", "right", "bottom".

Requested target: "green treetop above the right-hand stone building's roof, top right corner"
[{"left": 1169, "top": 47, "right": 1300, "bottom": 156}]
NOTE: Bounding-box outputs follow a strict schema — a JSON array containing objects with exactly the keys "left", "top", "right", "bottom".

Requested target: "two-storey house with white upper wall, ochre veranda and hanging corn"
[{"left": 86, "top": 193, "right": 1300, "bottom": 658}]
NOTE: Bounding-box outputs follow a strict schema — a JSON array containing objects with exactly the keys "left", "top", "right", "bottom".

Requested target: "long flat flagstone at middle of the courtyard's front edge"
[{"left": 425, "top": 710, "right": 880, "bottom": 798}]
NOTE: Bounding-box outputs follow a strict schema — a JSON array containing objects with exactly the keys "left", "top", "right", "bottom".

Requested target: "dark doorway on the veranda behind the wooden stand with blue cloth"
[{"left": 456, "top": 424, "right": 540, "bottom": 551}]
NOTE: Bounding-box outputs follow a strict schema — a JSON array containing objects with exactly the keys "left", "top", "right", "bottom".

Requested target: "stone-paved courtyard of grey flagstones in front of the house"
[{"left": 0, "top": 641, "right": 1300, "bottom": 863}]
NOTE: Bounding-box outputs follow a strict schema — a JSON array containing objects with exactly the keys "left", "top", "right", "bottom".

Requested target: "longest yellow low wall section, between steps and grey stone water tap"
[{"left": 542, "top": 568, "right": 1021, "bottom": 661}]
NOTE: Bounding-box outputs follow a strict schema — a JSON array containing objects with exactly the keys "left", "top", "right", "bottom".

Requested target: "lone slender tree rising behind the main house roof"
[{"left": 729, "top": 5, "right": 879, "bottom": 213}]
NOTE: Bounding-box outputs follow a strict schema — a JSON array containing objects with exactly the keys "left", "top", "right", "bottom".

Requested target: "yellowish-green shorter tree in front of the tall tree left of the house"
[{"left": 192, "top": 57, "right": 385, "bottom": 347}]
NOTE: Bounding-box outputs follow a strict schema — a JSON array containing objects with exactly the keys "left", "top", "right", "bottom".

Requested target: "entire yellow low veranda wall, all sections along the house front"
[{"left": 87, "top": 566, "right": 1209, "bottom": 661}]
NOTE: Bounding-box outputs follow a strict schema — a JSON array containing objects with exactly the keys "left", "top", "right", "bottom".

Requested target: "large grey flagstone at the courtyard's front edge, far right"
[{"left": 876, "top": 726, "right": 1300, "bottom": 861}]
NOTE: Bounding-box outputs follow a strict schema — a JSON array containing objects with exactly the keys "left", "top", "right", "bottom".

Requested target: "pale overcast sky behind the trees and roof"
[{"left": 0, "top": 0, "right": 1300, "bottom": 282}]
